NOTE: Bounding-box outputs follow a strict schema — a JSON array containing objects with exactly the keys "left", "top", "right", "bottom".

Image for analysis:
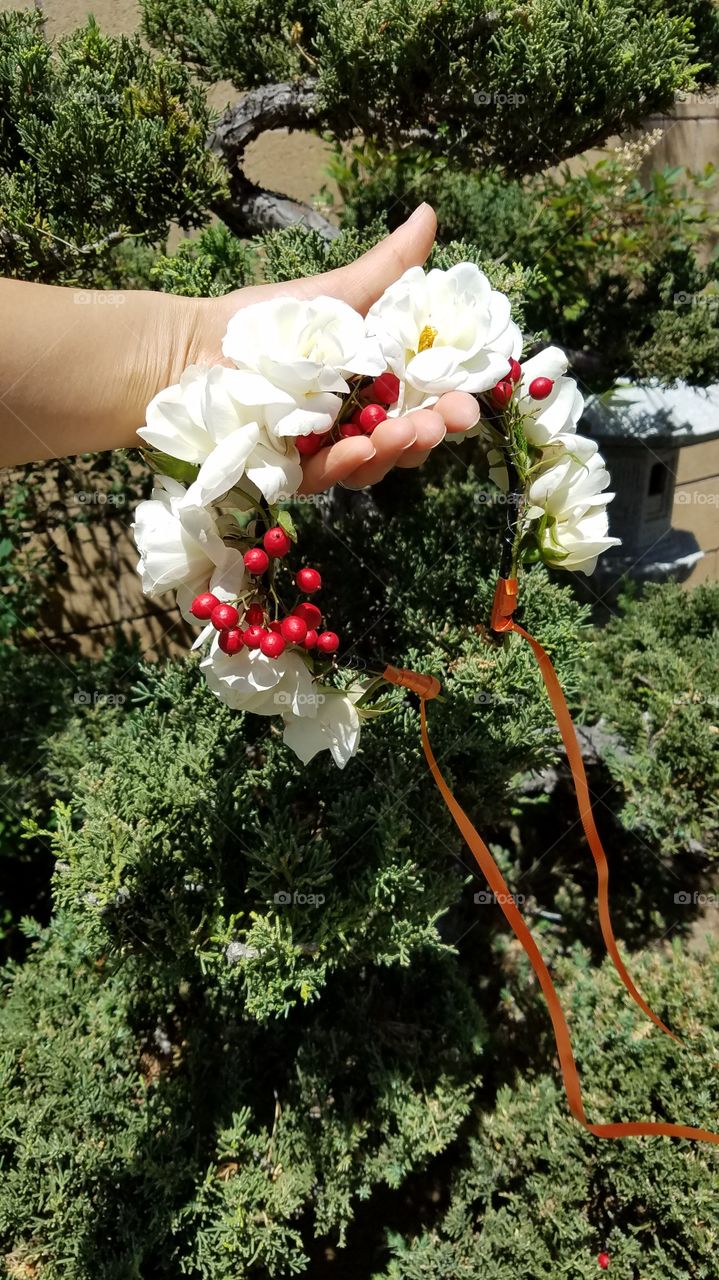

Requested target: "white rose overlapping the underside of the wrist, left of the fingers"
[{"left": 137, "top": 365, "right": 302, "bottom": 507}]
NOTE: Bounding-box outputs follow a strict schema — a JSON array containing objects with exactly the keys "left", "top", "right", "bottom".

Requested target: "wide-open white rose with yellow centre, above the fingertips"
[{"left": 367, "top": 262, "right": 514, "bottom": 415}]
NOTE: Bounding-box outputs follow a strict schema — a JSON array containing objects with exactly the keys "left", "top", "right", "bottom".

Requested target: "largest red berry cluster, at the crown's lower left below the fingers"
[{"left": 191, "top": 525, "right": 339, "bottom": 658}]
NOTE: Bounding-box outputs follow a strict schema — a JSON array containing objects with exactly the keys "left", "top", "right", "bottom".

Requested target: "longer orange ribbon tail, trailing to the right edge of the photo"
[{"left": 420, "top": 706, "right": 719, "bottom": 1146}]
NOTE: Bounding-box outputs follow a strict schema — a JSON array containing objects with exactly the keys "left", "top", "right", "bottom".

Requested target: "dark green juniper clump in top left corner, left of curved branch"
[{"left": 0, "top": 10, "right": 220, "bottom": 284}]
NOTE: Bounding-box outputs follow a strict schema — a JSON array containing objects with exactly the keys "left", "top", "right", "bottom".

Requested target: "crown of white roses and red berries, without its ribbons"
[{"left": 133, "top": 254, "right": 618, "bottom": 768}]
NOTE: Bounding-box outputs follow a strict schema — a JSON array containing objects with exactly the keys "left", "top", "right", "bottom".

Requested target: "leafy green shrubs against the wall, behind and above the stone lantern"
[{"left": 331, "top": 142, "right": 719, "bottom": 389}]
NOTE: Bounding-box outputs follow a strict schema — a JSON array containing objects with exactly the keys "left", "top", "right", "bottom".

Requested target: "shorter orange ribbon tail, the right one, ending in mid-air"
[{"left": 508, "top": 621, "right": 682, "bottom": 1044}]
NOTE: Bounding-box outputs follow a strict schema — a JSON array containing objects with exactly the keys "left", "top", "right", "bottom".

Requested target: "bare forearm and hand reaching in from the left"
[{"left": 0, "top": 205, "right": 480, "bottom": 493}]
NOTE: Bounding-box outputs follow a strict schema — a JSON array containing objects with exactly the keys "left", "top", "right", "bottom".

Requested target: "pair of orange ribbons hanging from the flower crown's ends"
[{"left": 384, "top": 579, "right": 719, "bottom": 1144}]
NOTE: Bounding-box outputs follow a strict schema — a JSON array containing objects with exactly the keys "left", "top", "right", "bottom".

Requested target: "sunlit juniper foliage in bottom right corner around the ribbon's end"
[{"left": 381, "top": 947, "right": 719, "bottom": 1280}]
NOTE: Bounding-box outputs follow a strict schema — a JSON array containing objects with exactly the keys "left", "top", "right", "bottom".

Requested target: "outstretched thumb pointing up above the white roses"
[{"left": 294, "top": 204, "right": 436, "bottom": 315}]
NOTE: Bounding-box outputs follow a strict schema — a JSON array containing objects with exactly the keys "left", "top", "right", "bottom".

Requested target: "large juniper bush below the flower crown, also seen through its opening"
[{"left": 0, "top": 453, "right": 583, "bottom": 1280}]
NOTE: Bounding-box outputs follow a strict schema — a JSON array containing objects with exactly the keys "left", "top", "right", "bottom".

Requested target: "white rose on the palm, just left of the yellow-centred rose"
[{"left": 223, "top": 297, "right": 385, "bottom": 435}]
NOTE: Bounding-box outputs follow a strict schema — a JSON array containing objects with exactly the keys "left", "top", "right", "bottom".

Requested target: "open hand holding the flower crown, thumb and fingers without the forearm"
[{"left": 184, "top": 205, "right": 480, "bottom": 493}]
